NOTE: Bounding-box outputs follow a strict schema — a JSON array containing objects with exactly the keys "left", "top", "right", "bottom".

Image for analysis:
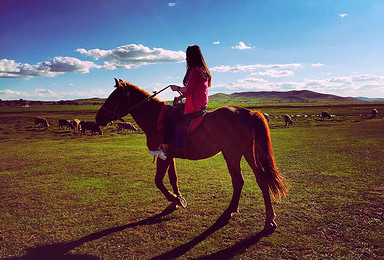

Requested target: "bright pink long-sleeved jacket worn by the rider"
[{"left": 180, "top": 66, "right": 208, "bottom": 114}]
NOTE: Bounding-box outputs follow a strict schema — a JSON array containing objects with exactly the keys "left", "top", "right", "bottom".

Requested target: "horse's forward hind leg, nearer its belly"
[{"left": 220, "top": 153, "right": 244, "bottom": 220}]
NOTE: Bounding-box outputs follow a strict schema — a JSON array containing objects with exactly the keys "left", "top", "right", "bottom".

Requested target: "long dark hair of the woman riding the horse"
[{"left": 183, "top": 45, "right": 211, "bottom": 87}]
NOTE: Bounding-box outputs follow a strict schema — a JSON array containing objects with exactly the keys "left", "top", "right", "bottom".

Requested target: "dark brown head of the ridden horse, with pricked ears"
[{"left": 96, "top": 78, "right": 131, "bottom": 126}]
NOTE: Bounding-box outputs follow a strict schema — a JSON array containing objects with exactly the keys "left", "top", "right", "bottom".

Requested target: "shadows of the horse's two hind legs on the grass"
[{"left": 152, "top": 218, "right": 274, "bottom": 260}]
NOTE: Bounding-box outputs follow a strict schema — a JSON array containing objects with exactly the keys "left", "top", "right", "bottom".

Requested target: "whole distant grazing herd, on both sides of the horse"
[{"left": 35, "top": 109, "right": 379, "bottom": 135}]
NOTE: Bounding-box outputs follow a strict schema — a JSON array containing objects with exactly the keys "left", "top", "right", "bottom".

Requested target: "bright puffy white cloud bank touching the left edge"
[{"left": 0, "top": 57, "right": 101, "bottom": 79}]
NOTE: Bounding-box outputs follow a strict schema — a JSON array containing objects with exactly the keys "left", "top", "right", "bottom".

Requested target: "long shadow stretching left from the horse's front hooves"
[{"left": 4, "top": 206, "right": 175, "bottom": 260}]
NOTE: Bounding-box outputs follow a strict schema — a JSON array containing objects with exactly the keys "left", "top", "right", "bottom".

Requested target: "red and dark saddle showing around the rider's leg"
[{"left": 157, "top": 105, "right": 206, "bottom": 149}]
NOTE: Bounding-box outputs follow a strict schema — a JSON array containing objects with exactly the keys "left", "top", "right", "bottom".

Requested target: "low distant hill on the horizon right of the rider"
[{"left": 209, "top": 90, "right": 359, "bottom": 103}]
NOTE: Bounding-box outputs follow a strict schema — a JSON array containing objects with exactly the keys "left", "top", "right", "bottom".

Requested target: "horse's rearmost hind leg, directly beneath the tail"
[{"left": 244, "top": 146, "right": 276, "bottom": 230}]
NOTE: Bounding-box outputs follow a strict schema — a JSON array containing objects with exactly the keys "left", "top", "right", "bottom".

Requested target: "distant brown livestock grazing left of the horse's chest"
[{"left": 35, "top": 117, "right": 138, "bottom": 135}]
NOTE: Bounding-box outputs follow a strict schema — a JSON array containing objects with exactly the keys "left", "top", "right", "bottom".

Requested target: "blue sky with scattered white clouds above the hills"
[{"left": 0, "top": 0, "right": 384, "bottom": 100}]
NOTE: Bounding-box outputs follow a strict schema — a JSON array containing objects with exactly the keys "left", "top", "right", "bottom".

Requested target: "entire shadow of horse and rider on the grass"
[{"left": 7, "top": 207, "right": 273, "bottom": 260}]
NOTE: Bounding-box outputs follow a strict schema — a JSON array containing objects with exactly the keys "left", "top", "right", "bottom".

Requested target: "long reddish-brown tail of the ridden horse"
[{"left": 252, "top": 112, "right": 288, "bottom": 201}]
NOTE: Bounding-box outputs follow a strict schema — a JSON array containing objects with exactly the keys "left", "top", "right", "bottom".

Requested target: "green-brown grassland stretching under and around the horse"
[{"left": 0, "top": 104, "right": 384, "bottom": 259}]
